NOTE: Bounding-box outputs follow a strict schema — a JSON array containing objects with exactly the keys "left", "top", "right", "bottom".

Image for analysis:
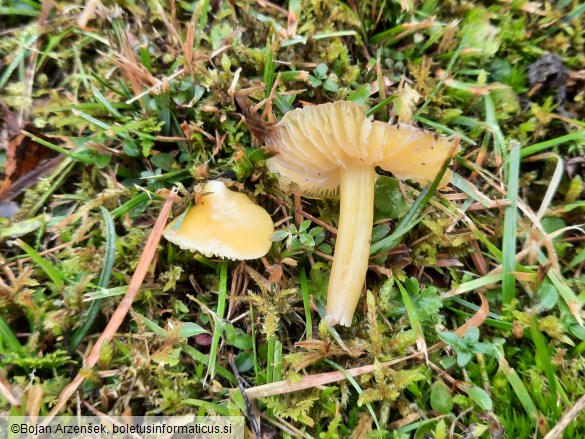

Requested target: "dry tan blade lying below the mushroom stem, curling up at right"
[{"left": 246, "top": 293, "right": 489, "bottom": 399}]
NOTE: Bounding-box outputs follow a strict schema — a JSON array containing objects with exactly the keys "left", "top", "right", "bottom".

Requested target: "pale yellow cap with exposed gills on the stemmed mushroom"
[{"left": 267, "top": 101, "right": 452, "bottom": 196}]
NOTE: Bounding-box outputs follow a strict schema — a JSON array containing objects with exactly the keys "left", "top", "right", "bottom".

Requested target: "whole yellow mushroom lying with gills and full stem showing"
[{"left": 266, "top": 101, "right": 452, "bottom": 326}]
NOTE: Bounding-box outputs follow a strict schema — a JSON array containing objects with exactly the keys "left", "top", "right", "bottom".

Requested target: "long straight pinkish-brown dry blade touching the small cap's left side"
[{"left": 43, "top": 188, "right": 177, "bottom": 425}]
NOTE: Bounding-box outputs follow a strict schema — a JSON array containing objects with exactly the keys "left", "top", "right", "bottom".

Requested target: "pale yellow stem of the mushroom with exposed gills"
[{"left": 326, "top": 164, "right": 377, "bottom": 326}]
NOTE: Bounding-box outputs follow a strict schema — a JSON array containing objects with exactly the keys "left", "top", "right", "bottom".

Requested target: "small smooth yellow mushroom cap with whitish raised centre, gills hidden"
[{"left": 163, "top": 181, "right": 274, "bottom": 260}]
